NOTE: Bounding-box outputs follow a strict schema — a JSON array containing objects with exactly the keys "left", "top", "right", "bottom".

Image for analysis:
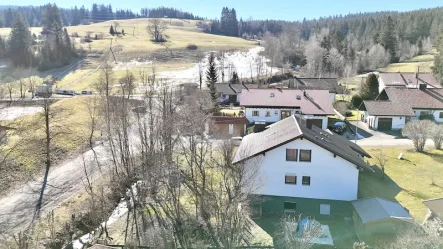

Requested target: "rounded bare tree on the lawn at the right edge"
[{"left": 402, "top": 120, "right": 433, "bottom": 152}]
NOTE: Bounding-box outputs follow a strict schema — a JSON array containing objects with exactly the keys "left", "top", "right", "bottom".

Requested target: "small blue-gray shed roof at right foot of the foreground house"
[{"left": 352, "top": 197, "right": 414, "bottom": 223}]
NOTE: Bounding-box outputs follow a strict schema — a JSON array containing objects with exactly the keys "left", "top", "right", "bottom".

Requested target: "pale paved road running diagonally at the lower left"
[{"left": 0, "top": 145, "right": 109, "bottom": 243}]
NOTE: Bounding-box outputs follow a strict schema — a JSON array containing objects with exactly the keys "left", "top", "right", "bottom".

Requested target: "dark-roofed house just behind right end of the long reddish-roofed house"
[{"left": 289, "top": 77, "right": 341, "bottom": 102}]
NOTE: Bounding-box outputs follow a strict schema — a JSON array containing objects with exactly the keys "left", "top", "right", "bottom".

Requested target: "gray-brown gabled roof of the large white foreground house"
[{"left": 233, "top": 116, "right": 373, "bottom": 171}]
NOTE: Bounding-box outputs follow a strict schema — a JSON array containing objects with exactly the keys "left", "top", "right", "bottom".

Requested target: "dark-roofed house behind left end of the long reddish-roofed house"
[{"left": 215, "top": 83, "right": 258, "bottom": 103}]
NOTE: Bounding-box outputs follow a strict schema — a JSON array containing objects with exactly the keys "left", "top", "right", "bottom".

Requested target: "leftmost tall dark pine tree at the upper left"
[{"left": 9, "top": 14, "right": 32, "bottom": 67}]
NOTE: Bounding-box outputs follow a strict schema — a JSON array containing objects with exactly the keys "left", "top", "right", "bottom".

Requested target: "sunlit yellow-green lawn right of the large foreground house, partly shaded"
[{"left": 359, "top": 147, "right": 443, "bottom": 220}]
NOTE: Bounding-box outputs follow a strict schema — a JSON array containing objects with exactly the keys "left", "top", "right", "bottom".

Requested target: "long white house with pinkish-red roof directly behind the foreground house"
[{"left": 240, "top": 89, "right": 335, "bottom": 129}]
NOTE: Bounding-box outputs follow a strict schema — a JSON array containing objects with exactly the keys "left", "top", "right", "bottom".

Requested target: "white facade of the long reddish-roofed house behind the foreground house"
[{"left": 245, "top": 108, "right": 328, "bottom": 130}]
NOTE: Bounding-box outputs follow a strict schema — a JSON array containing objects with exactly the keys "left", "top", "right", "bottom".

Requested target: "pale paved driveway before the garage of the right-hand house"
[{"left": 348, "top": 121, "right": 434, "bottom": 147}]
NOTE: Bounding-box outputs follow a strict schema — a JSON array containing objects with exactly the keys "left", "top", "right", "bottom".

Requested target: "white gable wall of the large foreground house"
[{"left": 250, "top": 139, "right": 358, "bottom": 201}]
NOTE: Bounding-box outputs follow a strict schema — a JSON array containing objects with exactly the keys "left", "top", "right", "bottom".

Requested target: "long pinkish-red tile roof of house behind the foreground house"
[{"left": 240, "top": 89, "right": 335, "bottom": 115}]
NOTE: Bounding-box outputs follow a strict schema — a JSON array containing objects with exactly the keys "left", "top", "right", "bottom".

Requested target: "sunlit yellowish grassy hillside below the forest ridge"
[{"left": 0, "top": 18, "right": 257, "bottom": 90}]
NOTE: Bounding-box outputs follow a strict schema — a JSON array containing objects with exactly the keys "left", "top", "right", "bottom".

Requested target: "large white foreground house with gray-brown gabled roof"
[{"left": 234, "top": 116, "right": 373, "bottom": 201}]
